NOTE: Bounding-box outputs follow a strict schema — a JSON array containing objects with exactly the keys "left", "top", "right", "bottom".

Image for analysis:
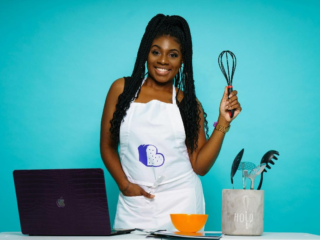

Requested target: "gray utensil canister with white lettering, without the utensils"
[{"left": 222, "top": 189, "right": 264, "bottom": 236}]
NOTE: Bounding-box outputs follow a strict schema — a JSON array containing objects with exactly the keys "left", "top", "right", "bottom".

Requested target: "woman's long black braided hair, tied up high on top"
[{"left": 110, "top": 14, "right": 209, "bottom": 153}]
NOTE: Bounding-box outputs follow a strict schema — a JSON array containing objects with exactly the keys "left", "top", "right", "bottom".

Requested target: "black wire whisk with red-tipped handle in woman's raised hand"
[{"left": 218, "top": 50, "right": 237, "bottom": 118}]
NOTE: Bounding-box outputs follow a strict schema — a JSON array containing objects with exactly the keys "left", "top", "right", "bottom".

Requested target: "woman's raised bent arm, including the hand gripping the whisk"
[{"left": 189, "top": 87, "right": 242, "bottom": 176}]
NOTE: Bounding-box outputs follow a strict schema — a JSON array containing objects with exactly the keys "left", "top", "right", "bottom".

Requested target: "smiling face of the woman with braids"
[{"left": 147, "top": 36, "right": 182, "bottom": 83}]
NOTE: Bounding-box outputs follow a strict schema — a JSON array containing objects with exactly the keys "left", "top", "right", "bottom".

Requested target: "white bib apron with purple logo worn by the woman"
[{"left": 114, "top": 79, "right": 205, "bottom": 231}]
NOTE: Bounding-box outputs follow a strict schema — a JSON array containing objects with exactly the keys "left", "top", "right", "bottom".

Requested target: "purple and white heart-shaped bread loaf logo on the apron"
[{"left": 138, "top": 144, "right": 164, "bottom": 167}]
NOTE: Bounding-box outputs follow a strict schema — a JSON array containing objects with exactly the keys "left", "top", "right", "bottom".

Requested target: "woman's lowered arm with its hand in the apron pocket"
[{"left": 100, "top": 78, "right": 154, "bottom": 198}]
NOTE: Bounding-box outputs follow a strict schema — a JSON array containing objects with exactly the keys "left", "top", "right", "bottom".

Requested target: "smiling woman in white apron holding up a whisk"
[{"left": 100, "top": 14, "right": 241, "bottom": 230}]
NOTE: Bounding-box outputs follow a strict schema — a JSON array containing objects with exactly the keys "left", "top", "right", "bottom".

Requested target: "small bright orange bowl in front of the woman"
[{"left": 170, "top": 214, "right": 208, "bottom": 233}]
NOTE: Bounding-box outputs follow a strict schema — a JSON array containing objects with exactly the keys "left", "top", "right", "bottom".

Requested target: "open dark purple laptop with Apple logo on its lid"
[{"left": 13, "top": 168, "right": 134, "bottom": 236}]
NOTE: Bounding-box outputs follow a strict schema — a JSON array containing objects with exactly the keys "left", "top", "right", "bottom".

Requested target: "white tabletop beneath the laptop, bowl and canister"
[{"left": 0, "top": 231, "right": 320, "bottom": 240}]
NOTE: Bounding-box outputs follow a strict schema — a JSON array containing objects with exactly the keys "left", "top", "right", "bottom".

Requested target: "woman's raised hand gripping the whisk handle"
[{"left": 220, "top": 87, "right": 242, "bottom": 123}]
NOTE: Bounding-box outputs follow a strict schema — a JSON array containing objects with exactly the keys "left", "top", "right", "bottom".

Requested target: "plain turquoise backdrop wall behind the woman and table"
[{"left": 0, "top": 0, "right": 320, "bottom": 234}]
